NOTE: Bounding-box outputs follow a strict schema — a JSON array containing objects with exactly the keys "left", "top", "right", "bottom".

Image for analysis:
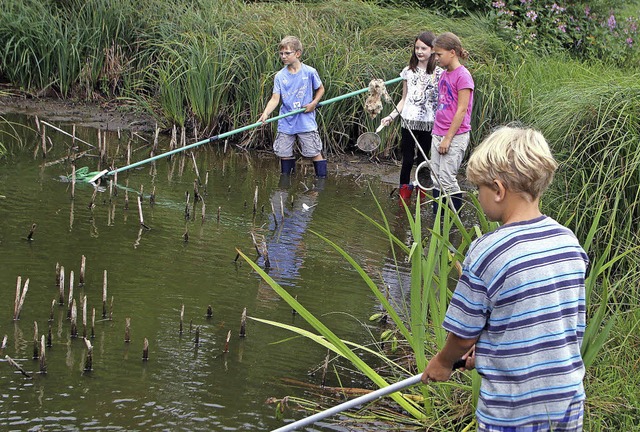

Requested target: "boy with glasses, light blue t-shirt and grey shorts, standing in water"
[{"left": 258, "top": 36, "right": 327, "bottom": 178}]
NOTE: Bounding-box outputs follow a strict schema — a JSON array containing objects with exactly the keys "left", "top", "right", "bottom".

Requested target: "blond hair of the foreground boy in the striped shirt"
[{"left": 467, "top": 126, "right": 558, "bottom": 199}]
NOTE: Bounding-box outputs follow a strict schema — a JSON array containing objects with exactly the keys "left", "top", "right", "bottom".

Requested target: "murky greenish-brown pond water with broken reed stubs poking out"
[{"left": 0, "top": 116, "right": 420, "bottom": 431}]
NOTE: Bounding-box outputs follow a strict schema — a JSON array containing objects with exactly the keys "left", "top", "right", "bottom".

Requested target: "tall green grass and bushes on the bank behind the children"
[{"left": 0, "top": 0, "right": 640, "bottom": 431}]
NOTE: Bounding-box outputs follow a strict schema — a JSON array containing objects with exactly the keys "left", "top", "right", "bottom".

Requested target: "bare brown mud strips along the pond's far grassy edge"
[{"left": 0, "top": 96, "right": 400, "bottom": 184}]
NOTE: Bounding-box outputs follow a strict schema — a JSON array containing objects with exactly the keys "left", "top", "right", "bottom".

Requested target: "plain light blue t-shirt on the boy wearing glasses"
[{"left": 273, "top": 63, "right": 322, "bottom": 135}]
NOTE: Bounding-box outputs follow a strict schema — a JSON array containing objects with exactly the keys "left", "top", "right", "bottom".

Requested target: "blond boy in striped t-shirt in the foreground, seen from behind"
[{"left": 422, "top": 127, "right": 588, "bottom": 432}]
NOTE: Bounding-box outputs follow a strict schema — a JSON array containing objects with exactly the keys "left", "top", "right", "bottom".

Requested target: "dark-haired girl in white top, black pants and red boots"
[{"left": 381, "top": 32, "right": 443, "bottom": 205}]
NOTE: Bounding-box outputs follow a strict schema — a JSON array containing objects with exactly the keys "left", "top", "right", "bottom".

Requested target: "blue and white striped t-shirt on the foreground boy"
[{"left": 443, "top": 216, "right": 588, "bottom": 426}]
